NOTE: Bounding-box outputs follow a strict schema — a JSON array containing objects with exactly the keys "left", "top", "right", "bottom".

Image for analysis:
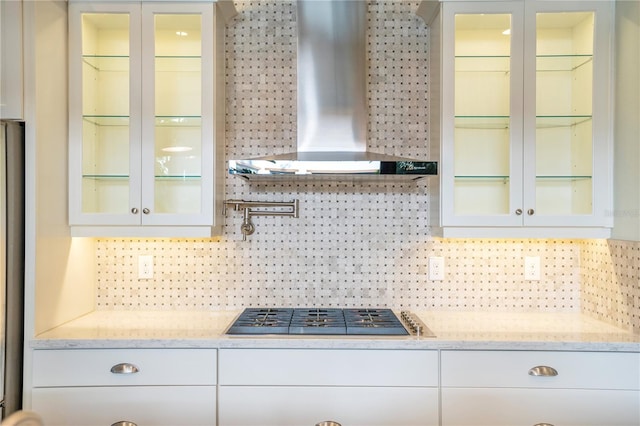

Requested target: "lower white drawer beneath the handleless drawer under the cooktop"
[{"left": 218, "top": 386, "right": 438, "bottom": 426}]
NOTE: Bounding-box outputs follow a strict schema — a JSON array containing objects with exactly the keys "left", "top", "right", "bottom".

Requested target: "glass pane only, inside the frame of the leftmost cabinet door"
[{"left": 79, "top": 13, "right": 134, "bottom": 214}]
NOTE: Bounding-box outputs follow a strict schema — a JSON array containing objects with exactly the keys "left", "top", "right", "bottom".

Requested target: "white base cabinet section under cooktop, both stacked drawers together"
[{"left": 218, "top": 349, "right": 438, "bottom": 426}]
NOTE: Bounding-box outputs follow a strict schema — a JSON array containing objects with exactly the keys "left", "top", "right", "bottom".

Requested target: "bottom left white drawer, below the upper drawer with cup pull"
[{"left": 32, "top": 386, "right": 216, "bottom": 426}]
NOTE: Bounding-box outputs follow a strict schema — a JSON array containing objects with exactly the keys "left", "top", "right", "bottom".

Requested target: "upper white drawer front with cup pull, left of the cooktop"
[{"left": 33, "top": 349, "right": 216, "bottom": 387}]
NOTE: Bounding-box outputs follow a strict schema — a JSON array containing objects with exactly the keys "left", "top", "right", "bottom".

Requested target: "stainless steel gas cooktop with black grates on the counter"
[{"left": 227, "top": 308, "right": 433, "bottom": 336}]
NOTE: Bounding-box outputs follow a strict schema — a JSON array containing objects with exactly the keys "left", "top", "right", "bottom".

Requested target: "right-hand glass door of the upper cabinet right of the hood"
[{"left": 525, "top": 2, "right": 610, "bottom": 226}]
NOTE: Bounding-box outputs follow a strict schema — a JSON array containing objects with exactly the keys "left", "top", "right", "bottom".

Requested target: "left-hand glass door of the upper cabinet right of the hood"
[{"left": 442, "top": 3, "right": 522, "bottom": 225}]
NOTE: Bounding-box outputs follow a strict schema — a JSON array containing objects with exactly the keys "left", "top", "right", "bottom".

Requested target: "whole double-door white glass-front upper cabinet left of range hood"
[{"left": 69, "top": 1, "right": 235, "bottom": 237}]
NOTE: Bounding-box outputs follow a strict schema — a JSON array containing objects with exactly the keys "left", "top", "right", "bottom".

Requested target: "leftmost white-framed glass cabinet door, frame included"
[{"left": 69, "top": 4, "right": 140, "bottom": 224}]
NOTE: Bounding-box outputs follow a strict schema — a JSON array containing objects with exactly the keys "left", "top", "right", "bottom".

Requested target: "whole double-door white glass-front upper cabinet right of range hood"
[{"left": 419, "top": 0, "right": 614, "bottom": 237}]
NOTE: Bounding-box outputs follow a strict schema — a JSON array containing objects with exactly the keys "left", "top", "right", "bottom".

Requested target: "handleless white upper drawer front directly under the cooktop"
[{"left": 219, "top": 349, "right": 438, "bottom": 386}]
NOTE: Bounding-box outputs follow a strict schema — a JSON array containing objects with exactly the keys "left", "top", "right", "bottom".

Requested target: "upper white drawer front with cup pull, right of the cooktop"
[{"left": 441, "top": 351, "right": 640, "bottom": 390}]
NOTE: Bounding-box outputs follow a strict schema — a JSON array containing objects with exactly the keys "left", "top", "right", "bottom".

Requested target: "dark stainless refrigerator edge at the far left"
[{"left": 0, "top": 121, "right": 25, "bottom": 418}]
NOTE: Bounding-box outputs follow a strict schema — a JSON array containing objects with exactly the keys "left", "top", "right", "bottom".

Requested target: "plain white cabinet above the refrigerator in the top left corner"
[{"left": 0, "top": 1, "right": 24, "bottom": 120}]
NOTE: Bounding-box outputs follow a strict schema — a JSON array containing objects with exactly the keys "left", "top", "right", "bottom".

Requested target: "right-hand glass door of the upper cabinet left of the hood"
[{"left": 142, "top": 5, "right": 213, "bottom": 224}]
